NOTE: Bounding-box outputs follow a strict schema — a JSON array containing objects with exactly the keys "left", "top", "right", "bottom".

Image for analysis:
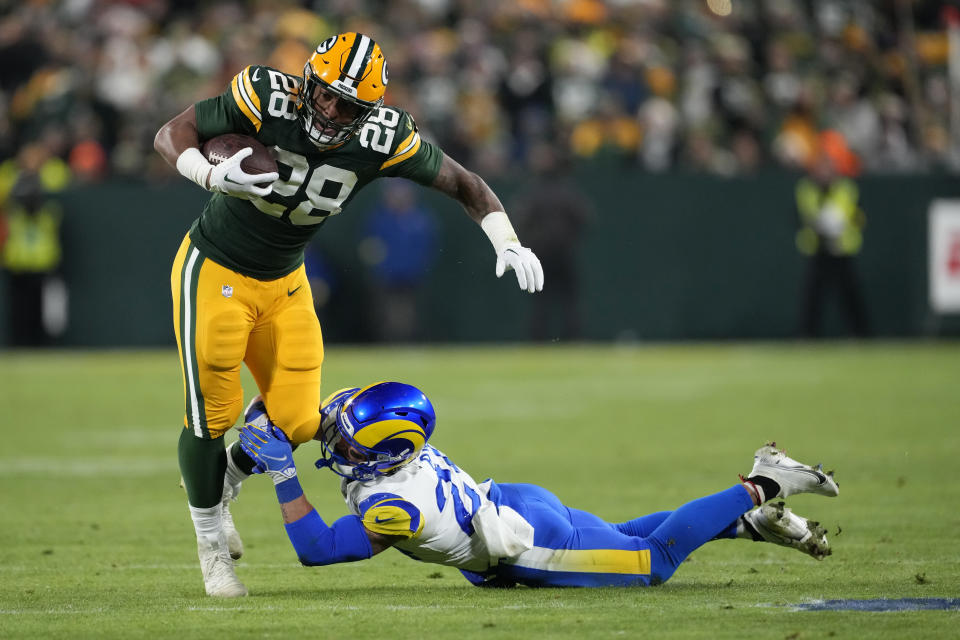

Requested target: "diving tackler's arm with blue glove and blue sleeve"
[{"left": 240, "top": 423, "right": 393, "bottom": 566}]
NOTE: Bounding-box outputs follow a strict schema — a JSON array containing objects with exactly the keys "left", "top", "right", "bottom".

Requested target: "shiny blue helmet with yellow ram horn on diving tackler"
[{"left": 316, "top": 382, "right": 437, "bottom": 480}]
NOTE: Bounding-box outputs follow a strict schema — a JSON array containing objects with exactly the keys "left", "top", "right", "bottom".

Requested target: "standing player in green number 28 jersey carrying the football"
[{"left": 154, "top": 33, "right": 543, "bottom": 597}]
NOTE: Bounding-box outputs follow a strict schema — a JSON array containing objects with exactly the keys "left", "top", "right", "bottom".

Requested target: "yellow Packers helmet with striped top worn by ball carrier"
[{"left": 297, "top": 32, "right": 387, "bottom": 149}]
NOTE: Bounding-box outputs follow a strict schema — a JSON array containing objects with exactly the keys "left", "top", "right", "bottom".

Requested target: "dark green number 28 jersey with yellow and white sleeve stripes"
[{"left": 190, "top": 66, "right": 443, "bottom": 280}]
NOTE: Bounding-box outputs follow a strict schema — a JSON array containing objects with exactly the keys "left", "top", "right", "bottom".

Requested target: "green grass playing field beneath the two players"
[{"left": 0, "top": 343, "right": 960, "bottom": 639}]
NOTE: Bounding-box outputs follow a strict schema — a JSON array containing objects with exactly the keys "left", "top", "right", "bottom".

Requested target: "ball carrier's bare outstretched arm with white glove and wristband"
[{"left": 432, "top": 154, "right": 543, "bottom": 293}]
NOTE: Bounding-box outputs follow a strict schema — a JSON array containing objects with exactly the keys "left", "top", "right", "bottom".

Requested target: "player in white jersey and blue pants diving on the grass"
[{"left": 240, "top": 382, "right": 839, "bottom": 587}]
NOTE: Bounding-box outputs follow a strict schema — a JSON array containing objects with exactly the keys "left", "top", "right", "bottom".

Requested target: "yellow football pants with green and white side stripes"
[{"left": 170, "top": 235, "right": 323, "bottom": 444}]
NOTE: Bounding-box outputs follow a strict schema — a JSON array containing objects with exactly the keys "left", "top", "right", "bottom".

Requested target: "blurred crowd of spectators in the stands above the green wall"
[{"left": 0, "top": 0, "right": 955, "bottom": 185}]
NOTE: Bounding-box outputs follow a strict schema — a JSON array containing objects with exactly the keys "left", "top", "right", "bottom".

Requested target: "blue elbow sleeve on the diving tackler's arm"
[{"left": 284, "top": 510, "right": 373, "bottom": 567}]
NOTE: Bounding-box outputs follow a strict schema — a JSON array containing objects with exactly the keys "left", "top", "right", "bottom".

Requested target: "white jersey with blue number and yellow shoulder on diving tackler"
[{"left": 341, "top": 444, "right": 496, "bottom": 571}]
